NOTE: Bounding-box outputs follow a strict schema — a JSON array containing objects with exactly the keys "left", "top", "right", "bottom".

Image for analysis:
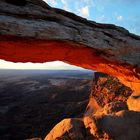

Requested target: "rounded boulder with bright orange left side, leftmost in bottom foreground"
[{"left": 45, "top": 119, "right": 86, "bottom": 140}]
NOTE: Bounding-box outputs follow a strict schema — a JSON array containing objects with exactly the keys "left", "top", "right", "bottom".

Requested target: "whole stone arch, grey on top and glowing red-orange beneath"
[{"left": 0, "top": 0, "right": 140, "bottom": 109}]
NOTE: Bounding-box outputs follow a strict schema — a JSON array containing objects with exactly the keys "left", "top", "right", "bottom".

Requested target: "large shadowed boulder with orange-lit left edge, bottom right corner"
[{"left": 84, "top": 110, "right": 140, "bottom": 140}]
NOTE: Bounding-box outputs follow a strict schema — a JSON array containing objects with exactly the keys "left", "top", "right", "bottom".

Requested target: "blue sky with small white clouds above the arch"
[{"left": 44, "top": 0, "right": 140, "bottom": 35}]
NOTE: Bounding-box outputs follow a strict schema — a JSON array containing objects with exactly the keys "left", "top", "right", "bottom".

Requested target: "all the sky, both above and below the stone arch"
[{"left": 0, "top": 0, "right": 140, "bottom": 69}]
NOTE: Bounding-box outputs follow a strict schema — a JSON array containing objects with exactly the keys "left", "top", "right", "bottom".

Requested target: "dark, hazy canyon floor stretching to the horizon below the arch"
[{"left": 0, "top": 70, "right": 93, "bottom": 140}]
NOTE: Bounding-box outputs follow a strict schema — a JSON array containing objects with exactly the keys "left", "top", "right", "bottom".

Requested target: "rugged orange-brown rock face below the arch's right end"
[{"left": 87, "top": 72, "right": 132, "bottom": 113}]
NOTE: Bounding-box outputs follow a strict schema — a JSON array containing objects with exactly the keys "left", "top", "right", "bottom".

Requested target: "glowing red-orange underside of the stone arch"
[{"left": 0, "top": 36, "right": 140, "bottom": 92}]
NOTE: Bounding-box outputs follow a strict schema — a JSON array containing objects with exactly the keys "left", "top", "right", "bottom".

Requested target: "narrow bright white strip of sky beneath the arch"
[{"left": 0, "top": 59, "right": 86, "bottom": 70}]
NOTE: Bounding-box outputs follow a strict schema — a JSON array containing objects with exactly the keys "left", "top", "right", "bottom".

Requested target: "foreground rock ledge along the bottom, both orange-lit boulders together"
[{"left": 45, "top": 104, "right": 140, "bottom": 140}]
